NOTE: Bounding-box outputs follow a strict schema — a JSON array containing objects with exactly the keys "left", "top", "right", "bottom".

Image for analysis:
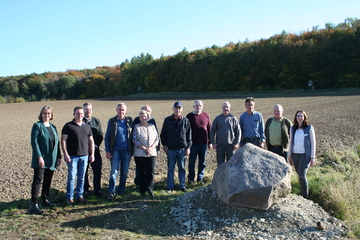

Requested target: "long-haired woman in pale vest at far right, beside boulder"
[{"left": 289, "top": 110, "right": 316, "bottom": 198}]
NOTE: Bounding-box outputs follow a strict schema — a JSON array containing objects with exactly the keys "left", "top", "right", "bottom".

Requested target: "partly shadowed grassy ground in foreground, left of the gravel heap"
[{"left": 0, "top": 180, "right": 208, "bottom": 239}]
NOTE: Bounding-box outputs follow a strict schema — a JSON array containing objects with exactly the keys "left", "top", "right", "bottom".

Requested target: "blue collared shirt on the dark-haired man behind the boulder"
[{"left": 240, "top": 111, "right": 265, "bottom": 145}]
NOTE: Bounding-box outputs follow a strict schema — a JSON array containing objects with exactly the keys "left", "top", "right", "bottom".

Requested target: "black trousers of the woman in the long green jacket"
[{"left": 31, "top": 168, "right": 54, "bottom": 203}]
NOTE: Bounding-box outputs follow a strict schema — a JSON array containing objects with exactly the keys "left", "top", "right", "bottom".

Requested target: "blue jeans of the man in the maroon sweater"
[{"left": 188, "top": 144, "right": 207, "bottom": 181}]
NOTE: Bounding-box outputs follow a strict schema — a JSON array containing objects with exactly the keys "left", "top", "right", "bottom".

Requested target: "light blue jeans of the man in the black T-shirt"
[{"left": 66, "top": 155, "right": 89, "bottom": 200}]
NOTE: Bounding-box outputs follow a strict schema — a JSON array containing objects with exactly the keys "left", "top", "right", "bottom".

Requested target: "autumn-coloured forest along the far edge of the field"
[{"left": 0, "top": 18, "right": 360, "bottom": 103}]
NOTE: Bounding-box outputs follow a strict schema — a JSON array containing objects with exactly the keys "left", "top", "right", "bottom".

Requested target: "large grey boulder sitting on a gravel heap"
[{"left": 211, "top": 143, "right": 291, "bottom": 210}]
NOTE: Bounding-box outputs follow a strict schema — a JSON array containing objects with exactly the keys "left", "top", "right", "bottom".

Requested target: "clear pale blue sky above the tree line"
[{"left": 0, "top": 0, "right": 360, "bottom": 76}]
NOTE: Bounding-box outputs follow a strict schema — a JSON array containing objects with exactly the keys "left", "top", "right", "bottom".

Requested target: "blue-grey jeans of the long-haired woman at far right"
[{"left": 291, "top": 153, "right": 310, "bottom": 198}]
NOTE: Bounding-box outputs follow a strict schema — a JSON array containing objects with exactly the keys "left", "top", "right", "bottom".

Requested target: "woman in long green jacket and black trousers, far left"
[{"left": 30, "top": 106, "right": 61, "bottom": 214}]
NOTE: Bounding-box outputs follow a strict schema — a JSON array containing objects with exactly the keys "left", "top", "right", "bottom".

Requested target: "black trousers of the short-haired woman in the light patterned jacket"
[{"left": 135, "top": 156, "right": 156, "bottom": 191}]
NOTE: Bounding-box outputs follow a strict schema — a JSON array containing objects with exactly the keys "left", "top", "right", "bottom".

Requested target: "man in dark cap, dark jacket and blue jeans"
[{"left": 160, "top": 102, "right": 192, "bottom": 193}]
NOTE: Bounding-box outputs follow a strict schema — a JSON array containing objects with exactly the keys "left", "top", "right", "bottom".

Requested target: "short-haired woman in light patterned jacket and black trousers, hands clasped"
[{"left": 133, "top": 110, "right": 159, "bottom": 196}]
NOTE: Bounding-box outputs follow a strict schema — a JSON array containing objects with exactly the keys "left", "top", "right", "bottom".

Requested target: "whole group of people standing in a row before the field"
[{"left": 30, "top": 97, "right": 316, "bottom": 214}]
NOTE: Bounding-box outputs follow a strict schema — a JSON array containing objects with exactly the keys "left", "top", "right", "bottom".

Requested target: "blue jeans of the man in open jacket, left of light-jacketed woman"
[{"left": 108, "top": 149, "right": 131, "bottom": 195}]
